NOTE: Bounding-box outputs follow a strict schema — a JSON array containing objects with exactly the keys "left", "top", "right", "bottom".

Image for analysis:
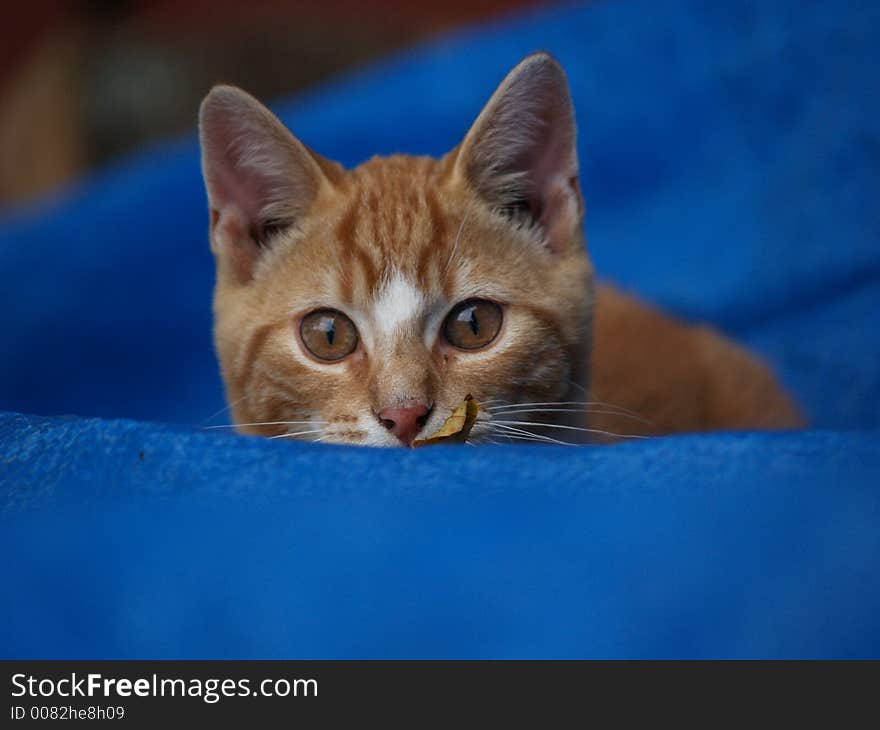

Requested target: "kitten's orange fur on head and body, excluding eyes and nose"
[{"left": 201, "top": 55, "right": 799, "bottom": 446}]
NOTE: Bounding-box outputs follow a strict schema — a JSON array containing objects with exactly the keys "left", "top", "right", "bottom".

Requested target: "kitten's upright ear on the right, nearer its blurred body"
[{"left": 455, "top": 53, "right": 583, "bottom": 252}]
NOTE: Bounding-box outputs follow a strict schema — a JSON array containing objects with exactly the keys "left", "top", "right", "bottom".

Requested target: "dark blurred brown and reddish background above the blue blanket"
[{"left": 0, "top": 0, "right": 552, "bottom": 208}]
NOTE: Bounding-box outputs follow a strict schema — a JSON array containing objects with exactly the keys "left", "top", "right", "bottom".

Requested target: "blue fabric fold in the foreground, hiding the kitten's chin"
[{"left": 0, "top": 415, "right": 880, "bottom": 658}]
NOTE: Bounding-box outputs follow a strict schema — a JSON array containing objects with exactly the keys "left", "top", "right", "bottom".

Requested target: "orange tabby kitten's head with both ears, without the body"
[{"left": 200, "top": 54, "right": 592, "bottom": 446}]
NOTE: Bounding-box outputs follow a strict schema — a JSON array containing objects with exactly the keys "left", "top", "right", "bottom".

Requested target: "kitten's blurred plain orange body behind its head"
[{"left": 590, "top": 285, "right": 803, "bottom": 435}]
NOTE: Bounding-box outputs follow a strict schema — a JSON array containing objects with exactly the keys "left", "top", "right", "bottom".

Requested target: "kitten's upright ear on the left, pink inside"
[{"left": 199, "top": 86, "right": 330, "bottom": 283}]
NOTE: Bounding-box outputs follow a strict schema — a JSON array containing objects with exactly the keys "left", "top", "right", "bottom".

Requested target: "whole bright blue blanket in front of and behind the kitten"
[{"left": 0, "top": 0, "right": 880, "bottom": 658}]
